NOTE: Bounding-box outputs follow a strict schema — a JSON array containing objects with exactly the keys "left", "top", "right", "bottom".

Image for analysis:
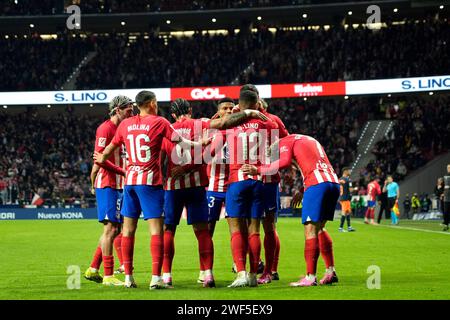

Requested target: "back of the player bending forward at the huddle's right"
[{"left": 288, "top": 134, "right": 339, "bottom": 190}]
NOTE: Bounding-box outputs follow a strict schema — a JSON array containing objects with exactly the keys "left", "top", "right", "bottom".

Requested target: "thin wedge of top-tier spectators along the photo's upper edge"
[{"left": 0, "top": 0, "right": 353, "bottom": 15}]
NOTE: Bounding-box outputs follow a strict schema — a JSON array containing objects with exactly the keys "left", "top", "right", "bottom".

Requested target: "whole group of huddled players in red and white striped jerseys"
[{"left": 85, "top": 84, "right": 340, "bottom": 289}]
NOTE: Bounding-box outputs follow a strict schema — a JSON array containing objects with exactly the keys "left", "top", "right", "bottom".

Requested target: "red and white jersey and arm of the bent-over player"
[{"left": 258, "top": 134, "right": 339, "bottom": 191}]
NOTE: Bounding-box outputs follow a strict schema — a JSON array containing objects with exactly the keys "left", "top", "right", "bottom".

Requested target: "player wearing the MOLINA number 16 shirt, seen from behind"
[{"left": 94, "top": 90, "right": 211, "bottom": 289}]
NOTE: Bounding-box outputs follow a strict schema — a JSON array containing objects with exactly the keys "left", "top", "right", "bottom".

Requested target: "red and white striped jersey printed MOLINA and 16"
[{"left": 112, "top": 115, "right": 180, "bottom": 186}]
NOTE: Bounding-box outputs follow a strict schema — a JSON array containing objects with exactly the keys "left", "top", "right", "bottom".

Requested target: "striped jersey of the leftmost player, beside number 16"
[{"left": 94, "top": 119, "right": 126, "bottom": 189}]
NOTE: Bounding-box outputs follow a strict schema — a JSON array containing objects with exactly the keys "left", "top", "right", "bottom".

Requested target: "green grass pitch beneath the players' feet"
[{"left": 0, "top": 218, "right": 450, "bottom": 300}]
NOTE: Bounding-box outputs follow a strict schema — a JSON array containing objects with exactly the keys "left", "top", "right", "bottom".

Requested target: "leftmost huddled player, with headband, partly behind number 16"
[{"left": 85, "top": 96, "right": 133, "bottom": 285}]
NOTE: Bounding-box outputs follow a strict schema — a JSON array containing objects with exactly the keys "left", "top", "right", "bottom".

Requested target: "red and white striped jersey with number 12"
[{"left": 226, "top": 119, "right": 277, "bottom": 183}]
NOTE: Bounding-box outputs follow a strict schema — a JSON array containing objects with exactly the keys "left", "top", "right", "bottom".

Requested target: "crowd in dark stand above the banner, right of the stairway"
[{"left": 77, "top": 21, "right": 450, "bottom": 89}]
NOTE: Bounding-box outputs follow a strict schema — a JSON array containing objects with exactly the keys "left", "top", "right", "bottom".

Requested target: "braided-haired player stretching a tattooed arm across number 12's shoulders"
[{"left": 163, "top": 99, "right": 267, "bottom": 287}]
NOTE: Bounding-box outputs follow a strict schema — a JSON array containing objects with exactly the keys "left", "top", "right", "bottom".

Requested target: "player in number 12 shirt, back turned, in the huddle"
[{"left": 224, "top": 90, "right": 276, "bottom": 287}]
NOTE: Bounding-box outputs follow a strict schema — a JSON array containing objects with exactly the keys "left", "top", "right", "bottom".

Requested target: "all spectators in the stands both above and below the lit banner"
[{"left": 0, "top": 13, "right": 450, "bottom": 203}]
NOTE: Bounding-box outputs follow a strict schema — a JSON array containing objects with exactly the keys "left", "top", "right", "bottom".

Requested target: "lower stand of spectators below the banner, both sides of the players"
[{"left": 0, "top": 95, "right": 450, "bottom": 206}]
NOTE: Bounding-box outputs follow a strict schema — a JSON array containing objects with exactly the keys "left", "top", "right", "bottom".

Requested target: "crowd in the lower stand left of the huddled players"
[{"left": 0, "top": 108, "right": 96, "bottom": 205}]
